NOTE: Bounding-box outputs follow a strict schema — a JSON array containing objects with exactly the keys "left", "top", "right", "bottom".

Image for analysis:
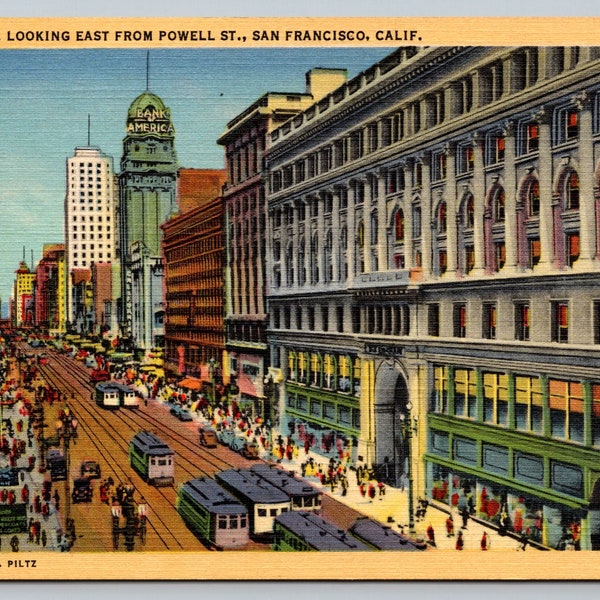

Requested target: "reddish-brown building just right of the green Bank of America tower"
[{"left": 162, "top": 170, "right": 225, "bottom": 383}]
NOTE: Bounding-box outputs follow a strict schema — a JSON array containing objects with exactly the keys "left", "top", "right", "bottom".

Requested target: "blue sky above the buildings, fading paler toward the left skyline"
[{"left": 0, "top": 48, "right": 392, "bottom": 304}]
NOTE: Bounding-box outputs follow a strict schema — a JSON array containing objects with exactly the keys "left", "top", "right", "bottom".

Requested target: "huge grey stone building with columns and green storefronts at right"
[{"left": 267, "top": 47, "right": 600, "bottom": 549}]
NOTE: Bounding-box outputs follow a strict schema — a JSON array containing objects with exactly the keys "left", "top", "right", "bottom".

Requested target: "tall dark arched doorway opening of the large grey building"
[{"left": 373, "top": 361, "right": 409, "bottom": 487}]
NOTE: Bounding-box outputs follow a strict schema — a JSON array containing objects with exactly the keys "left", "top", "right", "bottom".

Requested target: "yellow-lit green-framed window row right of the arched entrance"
[{"left": 430, "top": 365, "right": 600, "bottom": 446}]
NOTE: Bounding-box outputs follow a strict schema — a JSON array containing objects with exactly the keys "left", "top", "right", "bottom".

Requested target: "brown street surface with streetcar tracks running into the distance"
[{"left": 20, "top": 342, "right": 360, "bottom": 551}]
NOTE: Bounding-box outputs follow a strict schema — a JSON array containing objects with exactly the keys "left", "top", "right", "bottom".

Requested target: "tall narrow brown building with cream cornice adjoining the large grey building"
[{"left": 218, "top": 69, "right": 346, "bottom": 419}]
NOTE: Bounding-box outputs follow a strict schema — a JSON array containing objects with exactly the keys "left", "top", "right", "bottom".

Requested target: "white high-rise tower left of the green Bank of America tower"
[{"left": 64, "top": 145, "right": 118, "bottom": 333}]
